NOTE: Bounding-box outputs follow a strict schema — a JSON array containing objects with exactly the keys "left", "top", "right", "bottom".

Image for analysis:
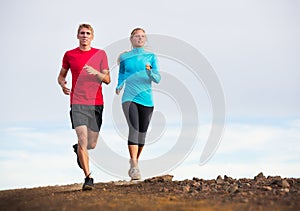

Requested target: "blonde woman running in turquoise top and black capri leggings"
[{"left": 116, "top": 28, "right": 161, "bottom": 180}]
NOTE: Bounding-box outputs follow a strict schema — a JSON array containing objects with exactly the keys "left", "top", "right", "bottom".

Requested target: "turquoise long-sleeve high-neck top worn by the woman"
[{"left": 116, "top": 48, "right": 161, "bottom": 107}]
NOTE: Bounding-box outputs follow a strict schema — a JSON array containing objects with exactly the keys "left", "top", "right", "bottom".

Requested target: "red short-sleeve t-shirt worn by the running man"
[{"left": 62, "top": 47, "right": 109, "bottom": 105}]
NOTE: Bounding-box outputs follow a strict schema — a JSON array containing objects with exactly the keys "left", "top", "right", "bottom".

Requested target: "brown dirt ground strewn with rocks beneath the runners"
[{"left": 0, "top": 173, "right": 300, "bottom": 210}]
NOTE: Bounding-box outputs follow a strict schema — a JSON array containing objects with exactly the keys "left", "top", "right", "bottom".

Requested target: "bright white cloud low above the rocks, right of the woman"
[{"left": 171, "top": 120, "right": 300, "bottom": 179}]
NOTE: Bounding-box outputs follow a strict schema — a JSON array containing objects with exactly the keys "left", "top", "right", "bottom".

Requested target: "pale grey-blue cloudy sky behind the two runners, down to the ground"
[{"left": 0, "top": 0, "right": 300, "bottom": 190}]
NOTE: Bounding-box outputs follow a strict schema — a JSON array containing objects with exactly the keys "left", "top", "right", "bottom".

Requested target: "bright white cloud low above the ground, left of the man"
[{"left": 0, "top": 127, "right": 118, "bottom": 189}]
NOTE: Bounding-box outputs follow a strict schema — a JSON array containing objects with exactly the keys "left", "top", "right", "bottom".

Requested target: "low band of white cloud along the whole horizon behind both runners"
[{"left": 0, "top": 120, "right": 300, "bottom": 189}]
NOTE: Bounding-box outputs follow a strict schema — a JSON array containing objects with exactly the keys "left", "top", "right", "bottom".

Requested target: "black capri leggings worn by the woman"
[{"left": 122, "top": 102, "right": 154, "bottom": 147}]
